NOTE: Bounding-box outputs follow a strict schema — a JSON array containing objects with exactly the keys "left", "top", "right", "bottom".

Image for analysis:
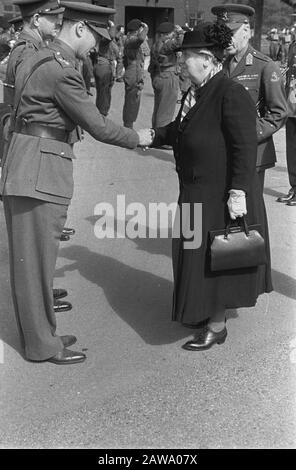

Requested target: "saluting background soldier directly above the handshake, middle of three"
[{"left": 122, "top": 18, "right": 148, "bottom": 129}]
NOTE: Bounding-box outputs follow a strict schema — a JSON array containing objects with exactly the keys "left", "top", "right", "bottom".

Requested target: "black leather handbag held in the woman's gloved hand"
[{"left": 210, "top": 217, "right": 266, "bottom": 271}]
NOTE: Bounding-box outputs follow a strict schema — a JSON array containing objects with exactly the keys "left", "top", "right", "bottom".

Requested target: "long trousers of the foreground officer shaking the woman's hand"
[{"left": 3, "top": 196, "right": 68, "bottom": 361}]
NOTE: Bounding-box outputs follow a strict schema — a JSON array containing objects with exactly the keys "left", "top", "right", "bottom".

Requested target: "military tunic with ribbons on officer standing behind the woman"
[{"left": 224, "top": 45, "right": 287, "bottom": 182}]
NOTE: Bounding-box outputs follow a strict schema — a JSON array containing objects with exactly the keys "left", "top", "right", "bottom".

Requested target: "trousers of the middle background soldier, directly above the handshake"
[{"left": 122, "top": 64, "right": 144, "bottom": 127}]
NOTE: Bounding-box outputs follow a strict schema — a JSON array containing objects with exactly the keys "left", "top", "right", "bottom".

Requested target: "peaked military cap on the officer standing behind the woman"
[{"left": 211, "top": 3, "right": 255, "bottom": 30}]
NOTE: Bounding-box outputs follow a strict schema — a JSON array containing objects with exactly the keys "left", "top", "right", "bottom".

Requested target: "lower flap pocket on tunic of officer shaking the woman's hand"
[{"left": 36, "top": 139, "right": 74, "bottom": 199}]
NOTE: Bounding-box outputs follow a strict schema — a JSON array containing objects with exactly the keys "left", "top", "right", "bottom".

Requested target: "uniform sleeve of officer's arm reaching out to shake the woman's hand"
[{"left": 54, "top": 68, "right": 139, "bottom": 148}]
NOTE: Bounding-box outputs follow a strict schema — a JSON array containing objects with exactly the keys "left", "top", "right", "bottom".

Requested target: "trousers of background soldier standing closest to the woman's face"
[{"left": 152, "top": 71, "right": 179, "bottom": 128}]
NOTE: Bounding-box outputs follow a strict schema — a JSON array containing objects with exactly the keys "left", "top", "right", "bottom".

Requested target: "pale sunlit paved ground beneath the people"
[{"left": 0, "top": 80, "right": 296, "bottom": 449}]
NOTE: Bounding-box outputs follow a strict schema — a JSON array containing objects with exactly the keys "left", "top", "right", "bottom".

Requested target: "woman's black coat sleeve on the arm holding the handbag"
[{"left": 222, "top": 82, "right": 257, "bottom": 192}]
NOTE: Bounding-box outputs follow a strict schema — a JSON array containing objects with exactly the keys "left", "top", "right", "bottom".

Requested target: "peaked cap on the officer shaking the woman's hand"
[{"left": 61, "top": 2, "right": 116, "bottom": 40}]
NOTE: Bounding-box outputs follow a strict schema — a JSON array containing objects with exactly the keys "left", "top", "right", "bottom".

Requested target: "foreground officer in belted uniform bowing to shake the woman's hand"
[{"left": 0, "top": 2, "right": 152, "bottom": 364}]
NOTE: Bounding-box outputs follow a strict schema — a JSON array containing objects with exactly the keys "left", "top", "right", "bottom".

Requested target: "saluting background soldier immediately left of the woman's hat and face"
[{"left": 148, "top": 22, "right": 184, "bottom": 128}]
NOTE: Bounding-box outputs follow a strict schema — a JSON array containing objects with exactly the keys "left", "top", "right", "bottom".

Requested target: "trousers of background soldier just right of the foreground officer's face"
[{"left": 94, "top": 63, "right": 114, "bottom": 116}]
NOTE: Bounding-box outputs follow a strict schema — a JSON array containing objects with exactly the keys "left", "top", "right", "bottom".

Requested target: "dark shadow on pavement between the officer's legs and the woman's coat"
[{"left": 56, "top": 245, "right": 191, "bottom": 344}]
